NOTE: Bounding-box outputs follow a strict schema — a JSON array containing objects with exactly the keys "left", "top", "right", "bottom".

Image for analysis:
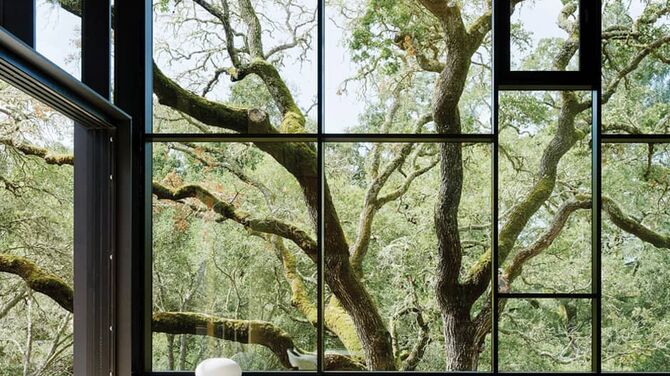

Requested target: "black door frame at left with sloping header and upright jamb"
[{"left": 0, "top": 22, "right": 130, "bottom": 376}]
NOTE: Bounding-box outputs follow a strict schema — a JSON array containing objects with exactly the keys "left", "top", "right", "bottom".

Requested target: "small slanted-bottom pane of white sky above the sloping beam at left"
[{"left": 35, "top": 0, "right": 81, "bottom": 78}]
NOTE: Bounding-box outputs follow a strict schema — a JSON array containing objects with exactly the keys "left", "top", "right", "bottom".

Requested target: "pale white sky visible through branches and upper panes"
[{"left": 36, "top": 0, "right": 643, "bottom": 133}]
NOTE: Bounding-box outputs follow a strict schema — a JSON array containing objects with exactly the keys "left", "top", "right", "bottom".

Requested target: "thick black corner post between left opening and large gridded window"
[{"left": 113, "top": 0, "right": 152, "bottom": 375}]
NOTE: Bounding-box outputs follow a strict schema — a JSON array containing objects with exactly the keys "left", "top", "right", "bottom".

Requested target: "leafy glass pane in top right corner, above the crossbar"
[{"left": 602, "top": 0, "right": 670, "bottom": 134}]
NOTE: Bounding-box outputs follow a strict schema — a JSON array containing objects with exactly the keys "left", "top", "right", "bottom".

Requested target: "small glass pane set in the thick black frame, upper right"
[{"left": 510, "top": 0, "right": 579, "bottom": 71}]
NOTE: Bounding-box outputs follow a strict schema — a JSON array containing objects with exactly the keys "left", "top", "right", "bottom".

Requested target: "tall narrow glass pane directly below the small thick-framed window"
[{"left": 498, "top": 91, "right": 591, "bottom": 293}]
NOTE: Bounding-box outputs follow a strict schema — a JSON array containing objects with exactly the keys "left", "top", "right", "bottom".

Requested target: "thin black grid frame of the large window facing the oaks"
[{"left": 143, "top": 0, "right": 670, "bottom": 376}]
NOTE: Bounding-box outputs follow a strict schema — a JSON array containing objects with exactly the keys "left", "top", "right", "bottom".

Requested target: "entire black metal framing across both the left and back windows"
[{"left": 5, "top": 0, "right": 670, "bottom": 376}]
